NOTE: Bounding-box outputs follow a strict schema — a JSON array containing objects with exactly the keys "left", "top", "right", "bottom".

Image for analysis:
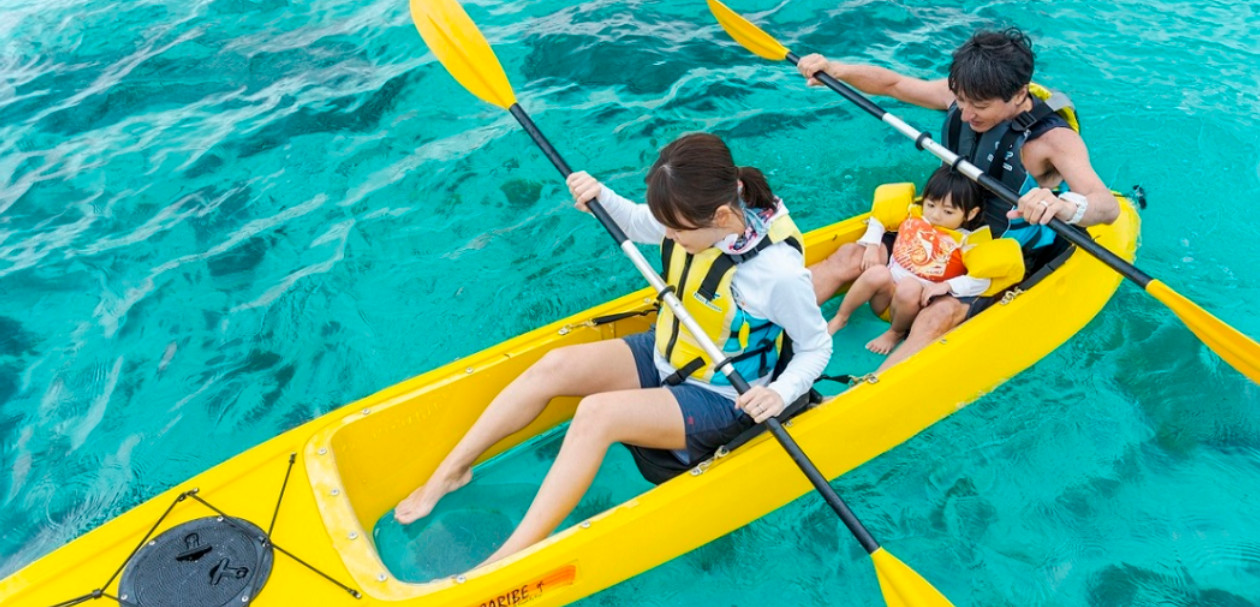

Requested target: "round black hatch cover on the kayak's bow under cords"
[{"left": 118, "top": 516, "right": 272, "bottom": 607}]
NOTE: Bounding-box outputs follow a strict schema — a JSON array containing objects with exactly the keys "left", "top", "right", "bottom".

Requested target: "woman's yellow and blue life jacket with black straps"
[{"left": 656, "top": 214, "right": 804, "bottom": 385}]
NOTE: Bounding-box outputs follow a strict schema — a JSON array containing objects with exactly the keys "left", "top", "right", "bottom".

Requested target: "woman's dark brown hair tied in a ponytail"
[{"left": 645, "top": 132, "right": 776, "bottom": 229}]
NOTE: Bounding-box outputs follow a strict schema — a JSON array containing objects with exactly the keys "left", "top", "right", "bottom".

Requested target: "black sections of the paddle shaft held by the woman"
[{"left": 508, "top": 103, "right": 879, "bottom": 554}]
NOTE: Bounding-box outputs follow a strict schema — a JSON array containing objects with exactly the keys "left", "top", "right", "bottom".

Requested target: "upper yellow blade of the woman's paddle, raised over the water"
[{"left": 411, "top": 0, "right": 517, "bottom": 110}]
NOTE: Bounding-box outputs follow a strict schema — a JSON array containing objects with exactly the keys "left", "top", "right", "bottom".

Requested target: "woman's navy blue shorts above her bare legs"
[{"left": 624, "top": 331, "right": 752, "bottom": 465}]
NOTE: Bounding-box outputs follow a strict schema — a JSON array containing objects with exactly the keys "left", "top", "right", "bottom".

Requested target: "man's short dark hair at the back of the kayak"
[{"left": 949, "top": 28, "right": 1033, "bottom": 101}]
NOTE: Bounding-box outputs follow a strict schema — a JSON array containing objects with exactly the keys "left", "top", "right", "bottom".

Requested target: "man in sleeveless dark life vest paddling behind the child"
[{"left": 798, "top": 28, "right": 1120, "bottom": 372}]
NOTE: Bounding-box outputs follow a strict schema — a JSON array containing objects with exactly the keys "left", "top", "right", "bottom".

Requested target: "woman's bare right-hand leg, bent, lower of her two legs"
[{"left": 483, "top": 388, "right": 687, "bottom": 564}]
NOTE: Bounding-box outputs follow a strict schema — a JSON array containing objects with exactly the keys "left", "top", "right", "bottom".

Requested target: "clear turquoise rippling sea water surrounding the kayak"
[{"left": 0, "top": 0, "right": 1260, "bottom": 607}]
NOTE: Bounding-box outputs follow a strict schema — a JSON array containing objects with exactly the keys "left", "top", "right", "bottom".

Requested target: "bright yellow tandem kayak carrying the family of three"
[{"left": 0, "top": 192, "right": 1139, "bottom": 607}]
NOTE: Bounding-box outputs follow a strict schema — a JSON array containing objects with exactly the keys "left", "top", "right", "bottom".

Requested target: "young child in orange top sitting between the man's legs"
[{"left": 827, "top": 166, "right": 989, "bottom": 354}]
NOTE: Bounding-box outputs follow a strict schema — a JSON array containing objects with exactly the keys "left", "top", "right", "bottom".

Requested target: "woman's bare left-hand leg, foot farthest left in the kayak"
[{"left": 394, "top": 339, "right": 639, "bottom": 525}]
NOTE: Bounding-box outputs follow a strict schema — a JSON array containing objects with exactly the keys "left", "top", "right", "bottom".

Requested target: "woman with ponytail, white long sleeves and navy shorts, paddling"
[{"left": 394, "top": 133, "right": 832, "bottom": 563}]
